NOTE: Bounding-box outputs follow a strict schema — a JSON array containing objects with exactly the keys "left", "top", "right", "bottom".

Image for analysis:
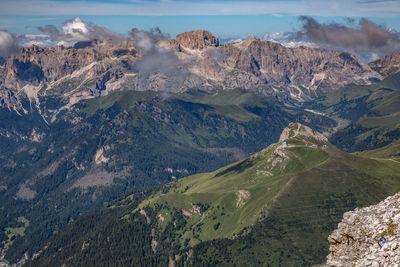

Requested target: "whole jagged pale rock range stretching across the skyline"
[{"left": 0, "top": 30, "right": 382, "bottom": 114}]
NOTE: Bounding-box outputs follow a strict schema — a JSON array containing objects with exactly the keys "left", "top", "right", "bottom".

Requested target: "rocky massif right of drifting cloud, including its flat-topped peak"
[{"left": 171, "top": 34, "right": 382, "bottom": 101}]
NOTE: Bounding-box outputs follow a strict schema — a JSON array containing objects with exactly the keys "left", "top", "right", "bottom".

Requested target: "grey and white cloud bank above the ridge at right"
[{"left": 224, "top": 16, "right": 400, "bottom": 62}]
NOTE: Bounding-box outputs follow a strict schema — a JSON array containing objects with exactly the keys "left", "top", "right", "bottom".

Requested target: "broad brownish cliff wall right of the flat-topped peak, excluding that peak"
[{"left": 222, "top": 38, "right": 380, "bottom": 88}]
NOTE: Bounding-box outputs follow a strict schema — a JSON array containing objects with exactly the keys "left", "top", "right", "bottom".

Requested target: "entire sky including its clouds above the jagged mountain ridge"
[{"left": 0, "top": 0, "right": 400, "bottom": 62}]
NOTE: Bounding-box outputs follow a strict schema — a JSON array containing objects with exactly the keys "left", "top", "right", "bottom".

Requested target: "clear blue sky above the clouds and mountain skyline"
[{"left": 0, "top": 0, "right": 400, "bottom": 38}]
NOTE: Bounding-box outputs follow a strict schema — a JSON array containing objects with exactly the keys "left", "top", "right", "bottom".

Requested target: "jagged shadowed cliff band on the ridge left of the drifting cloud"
[{"left": 1, "top": 41, "right": 136, "bottom": 84}]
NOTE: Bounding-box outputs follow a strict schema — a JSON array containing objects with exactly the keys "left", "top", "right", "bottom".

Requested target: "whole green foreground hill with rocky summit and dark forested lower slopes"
[{"left": 27, "top": 123, "right": 400, "bottom": 266}]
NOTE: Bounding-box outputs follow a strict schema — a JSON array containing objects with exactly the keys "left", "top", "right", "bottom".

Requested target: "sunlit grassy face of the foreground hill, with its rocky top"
[{"left": 131, "top": 124, "right": 334, "bottom": 244}]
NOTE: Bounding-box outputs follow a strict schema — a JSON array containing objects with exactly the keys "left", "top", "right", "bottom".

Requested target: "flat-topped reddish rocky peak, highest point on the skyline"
[{"left": 176, "top": 30, "right": 219, "bottom": 50}]
